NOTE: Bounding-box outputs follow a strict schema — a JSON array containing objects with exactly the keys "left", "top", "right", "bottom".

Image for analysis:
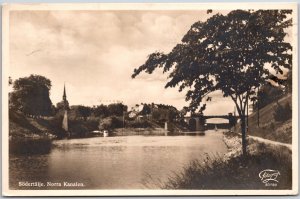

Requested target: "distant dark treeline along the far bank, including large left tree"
[{"left": 9, "top": 75, "right": 180, "bottom": 121}]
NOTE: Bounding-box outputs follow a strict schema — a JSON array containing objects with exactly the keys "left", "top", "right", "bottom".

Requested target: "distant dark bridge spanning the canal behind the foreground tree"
[{"left": 184, "top": 113, "right": 238, "bottom": 131}]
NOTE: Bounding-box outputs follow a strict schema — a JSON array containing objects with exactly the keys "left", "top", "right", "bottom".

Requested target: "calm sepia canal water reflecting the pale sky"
[{"left": 9, "top": 131, "right": 227, "bottom": 189}]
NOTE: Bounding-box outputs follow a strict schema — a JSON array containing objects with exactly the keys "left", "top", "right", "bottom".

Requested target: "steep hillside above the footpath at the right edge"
[{"left": 236, "top": 94, "right": 292, "bottom": 144}]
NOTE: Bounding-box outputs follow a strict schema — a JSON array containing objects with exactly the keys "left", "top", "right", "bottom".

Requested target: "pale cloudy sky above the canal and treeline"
[{"left": 9, "top": 10, "right": 255, "bottom": 114}]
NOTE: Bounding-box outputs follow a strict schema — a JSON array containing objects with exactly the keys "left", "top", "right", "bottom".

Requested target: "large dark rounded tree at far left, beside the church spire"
[{"left": 10, "top": 75, "right": 53, "bottom": 117}]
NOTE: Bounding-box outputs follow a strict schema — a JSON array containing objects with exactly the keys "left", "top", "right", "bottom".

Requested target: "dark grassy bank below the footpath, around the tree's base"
[{"left": 161, "top": 131, "right": 292, "bottom": 189}]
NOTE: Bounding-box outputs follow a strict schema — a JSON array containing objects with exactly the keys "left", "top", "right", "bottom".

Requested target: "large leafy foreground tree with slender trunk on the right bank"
[{"left": 132, "top": 10, "right": 292, "bottom": 154}]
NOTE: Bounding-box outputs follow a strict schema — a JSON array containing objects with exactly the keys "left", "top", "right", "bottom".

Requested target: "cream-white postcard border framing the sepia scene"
[{"left": 2, "top": 2, "right": 299, "bottom": 196}]
